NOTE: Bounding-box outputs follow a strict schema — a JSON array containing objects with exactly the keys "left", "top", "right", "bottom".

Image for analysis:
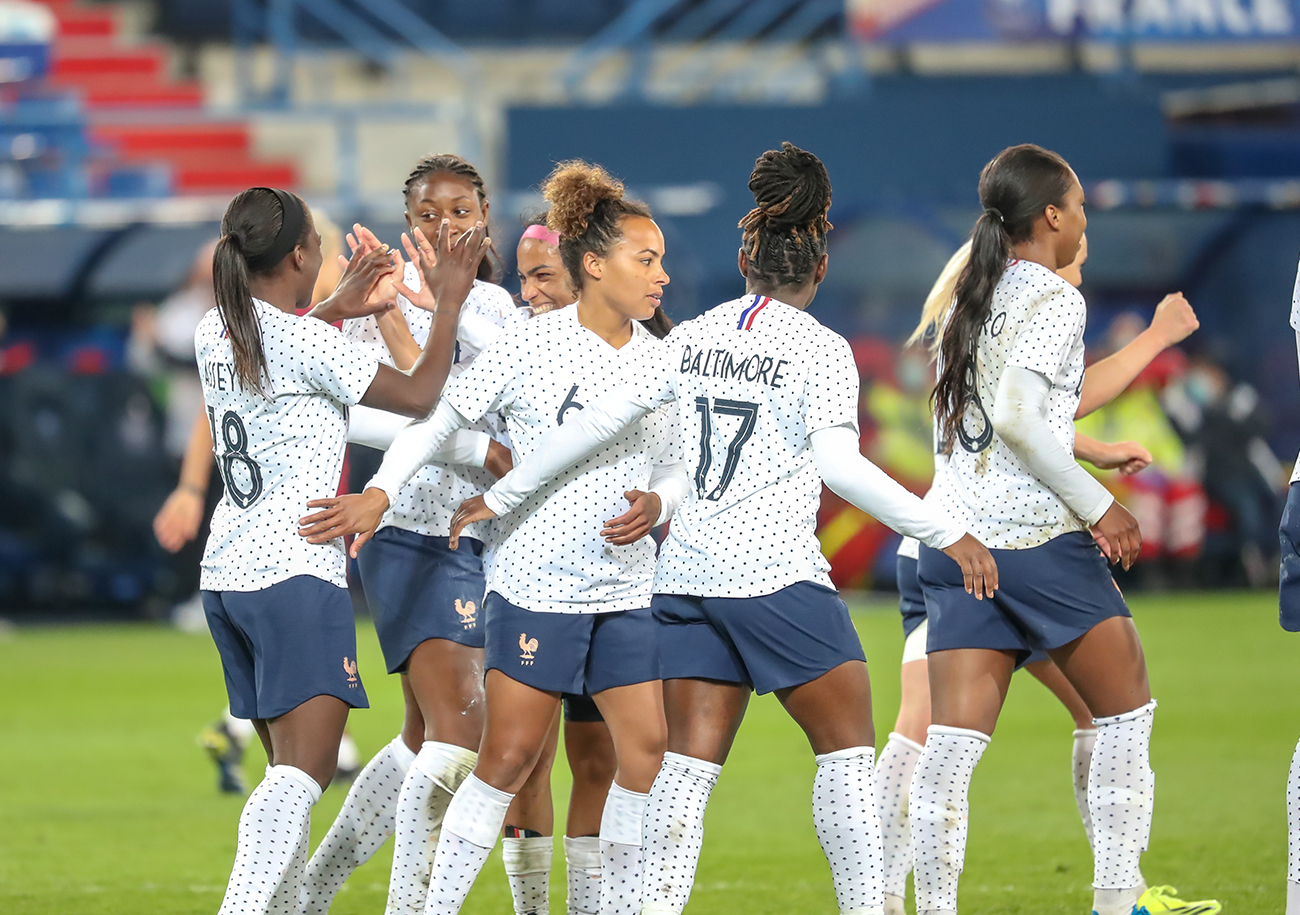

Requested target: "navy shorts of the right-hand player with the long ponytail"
[{"left": 918, "top": 530, "right": 1131, "bottom": 664}]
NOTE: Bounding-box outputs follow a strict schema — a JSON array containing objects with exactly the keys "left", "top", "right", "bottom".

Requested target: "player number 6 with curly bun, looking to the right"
[{"left": 301, "top": 162, "right": 686, "bottom": 915}]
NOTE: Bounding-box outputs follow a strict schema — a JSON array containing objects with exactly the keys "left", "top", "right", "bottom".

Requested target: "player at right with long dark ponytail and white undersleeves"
[{"left": 910, "top": 146, "right": 1156, "bottom": 915}]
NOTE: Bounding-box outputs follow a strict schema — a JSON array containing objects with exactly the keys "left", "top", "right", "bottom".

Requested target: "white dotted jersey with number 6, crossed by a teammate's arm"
[{"left": 371, "top": 305, "right": 681, "bottom": 613}]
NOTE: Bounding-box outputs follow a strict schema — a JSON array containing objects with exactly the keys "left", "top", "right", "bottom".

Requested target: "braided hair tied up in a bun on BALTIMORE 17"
[{"left": 740, "top": 142, "right": 831, "bottom": 289}]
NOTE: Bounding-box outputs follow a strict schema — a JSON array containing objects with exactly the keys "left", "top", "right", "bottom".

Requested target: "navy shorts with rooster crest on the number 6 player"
[{"left": 484, "top": 591, "right": 659, "bottom": 694}]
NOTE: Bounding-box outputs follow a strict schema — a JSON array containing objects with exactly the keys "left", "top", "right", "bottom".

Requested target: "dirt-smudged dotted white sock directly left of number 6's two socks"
[{"left": 384, "top": 741, "right": 478, "bottom": 915}]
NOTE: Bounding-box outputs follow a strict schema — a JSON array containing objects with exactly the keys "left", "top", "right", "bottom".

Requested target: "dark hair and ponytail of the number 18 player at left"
[{"left": 212, "top": 187, "right": 311, "bottom": 394}]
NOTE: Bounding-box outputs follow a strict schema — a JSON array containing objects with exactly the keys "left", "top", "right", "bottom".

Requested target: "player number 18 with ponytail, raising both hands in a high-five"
[{"left": 195, "top": 187, "right": 486, "bottom": 915}]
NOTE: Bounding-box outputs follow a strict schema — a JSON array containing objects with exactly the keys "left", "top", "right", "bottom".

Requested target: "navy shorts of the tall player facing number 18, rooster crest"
[{"left": 356, "top": 526, "right": 486, "bottom": 673}]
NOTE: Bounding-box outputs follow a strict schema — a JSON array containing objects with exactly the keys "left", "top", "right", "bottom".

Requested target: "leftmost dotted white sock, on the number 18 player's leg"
[{"left": 218, "top": 766, "right": 321, "bottom": 915}]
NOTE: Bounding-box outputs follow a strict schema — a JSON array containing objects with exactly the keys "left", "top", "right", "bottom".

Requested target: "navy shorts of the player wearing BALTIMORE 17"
[{"left": 650, "top": 581, "right": 867, "bottom": 694}]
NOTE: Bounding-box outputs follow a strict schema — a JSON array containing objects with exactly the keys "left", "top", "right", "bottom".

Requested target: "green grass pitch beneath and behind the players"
[{"left": 0, "top": 594, "right": 1300, "bottom": 915}]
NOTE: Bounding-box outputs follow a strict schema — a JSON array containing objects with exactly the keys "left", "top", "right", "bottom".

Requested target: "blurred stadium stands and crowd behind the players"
[{"left": 0, "top": 0, "right": 1300, "bottom": 616}]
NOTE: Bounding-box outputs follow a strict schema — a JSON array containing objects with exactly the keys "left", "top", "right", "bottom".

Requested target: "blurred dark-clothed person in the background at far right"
[{"left": 1164, "top": 354, "right": 1287, "bottom": 587}]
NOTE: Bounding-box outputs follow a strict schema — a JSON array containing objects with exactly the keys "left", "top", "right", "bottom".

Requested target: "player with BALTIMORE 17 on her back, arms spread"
[{"left": 452, "top": 143, "right": 997, "bottom": 914}]
